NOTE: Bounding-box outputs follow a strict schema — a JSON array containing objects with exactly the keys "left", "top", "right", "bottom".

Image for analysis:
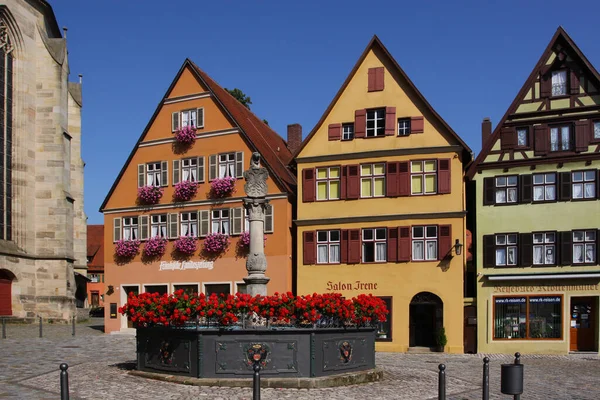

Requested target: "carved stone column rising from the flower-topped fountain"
[{"left": 244, "top": 153, "right": 270, "bottom": 296}]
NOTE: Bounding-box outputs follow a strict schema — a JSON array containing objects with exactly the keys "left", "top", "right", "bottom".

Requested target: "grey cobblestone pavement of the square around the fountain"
[{"left": 0, "top": 321, "right": 600, "bottom": 400}]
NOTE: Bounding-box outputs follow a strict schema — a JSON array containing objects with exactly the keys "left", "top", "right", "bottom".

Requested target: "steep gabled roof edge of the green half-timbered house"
[{"left": 467, "top": 26, "right": 600, "bottom": 179}]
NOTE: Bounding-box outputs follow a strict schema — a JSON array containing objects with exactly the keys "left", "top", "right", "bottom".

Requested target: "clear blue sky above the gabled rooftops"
[{"left": 50, "top": 0, "right": 600, "bottom": 224}]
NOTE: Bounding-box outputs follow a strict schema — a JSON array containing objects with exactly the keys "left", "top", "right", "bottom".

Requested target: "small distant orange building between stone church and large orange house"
[{"left": 87, "top": 225, "right": 105, "bottom": 307}]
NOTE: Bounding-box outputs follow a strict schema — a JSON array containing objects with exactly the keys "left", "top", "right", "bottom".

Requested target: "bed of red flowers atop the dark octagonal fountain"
[{"left": 119, "top": 290, "right": 388, "bottom": 327}]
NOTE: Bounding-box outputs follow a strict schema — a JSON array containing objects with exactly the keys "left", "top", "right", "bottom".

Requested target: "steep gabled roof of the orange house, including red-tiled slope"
[{"left": 100, "top": 58, "right": 296, "bottom": 212}]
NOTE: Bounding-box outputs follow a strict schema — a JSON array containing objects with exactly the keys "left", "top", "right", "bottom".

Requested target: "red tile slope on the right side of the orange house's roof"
[{"left": 190, "top": 61, "right": 296, "bottom": 191}]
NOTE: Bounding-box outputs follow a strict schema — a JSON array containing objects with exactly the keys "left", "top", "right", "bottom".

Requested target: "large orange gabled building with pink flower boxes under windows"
[{"left": 100, "top": 60, "right": 301, "bottom": 332}]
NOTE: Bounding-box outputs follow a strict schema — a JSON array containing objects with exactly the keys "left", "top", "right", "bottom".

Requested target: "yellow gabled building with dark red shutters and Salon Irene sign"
[{"left": 295, "top": 37, "right": 471, "bottom": 353}]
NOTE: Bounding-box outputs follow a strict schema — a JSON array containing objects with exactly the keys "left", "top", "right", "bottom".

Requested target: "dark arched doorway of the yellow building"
[{"left": 409, "top": 292, "right": 444, "bottom": 347}]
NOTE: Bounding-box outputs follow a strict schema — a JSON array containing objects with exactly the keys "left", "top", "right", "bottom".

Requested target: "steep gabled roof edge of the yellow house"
[{"left": 294, "top": 35, "right": 472, "bottom": 165}]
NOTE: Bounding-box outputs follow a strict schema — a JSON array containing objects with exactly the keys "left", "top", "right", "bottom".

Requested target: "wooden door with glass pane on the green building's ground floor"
[{"left": 569, "top": 297, "right": 598, "bottom": 351}]
